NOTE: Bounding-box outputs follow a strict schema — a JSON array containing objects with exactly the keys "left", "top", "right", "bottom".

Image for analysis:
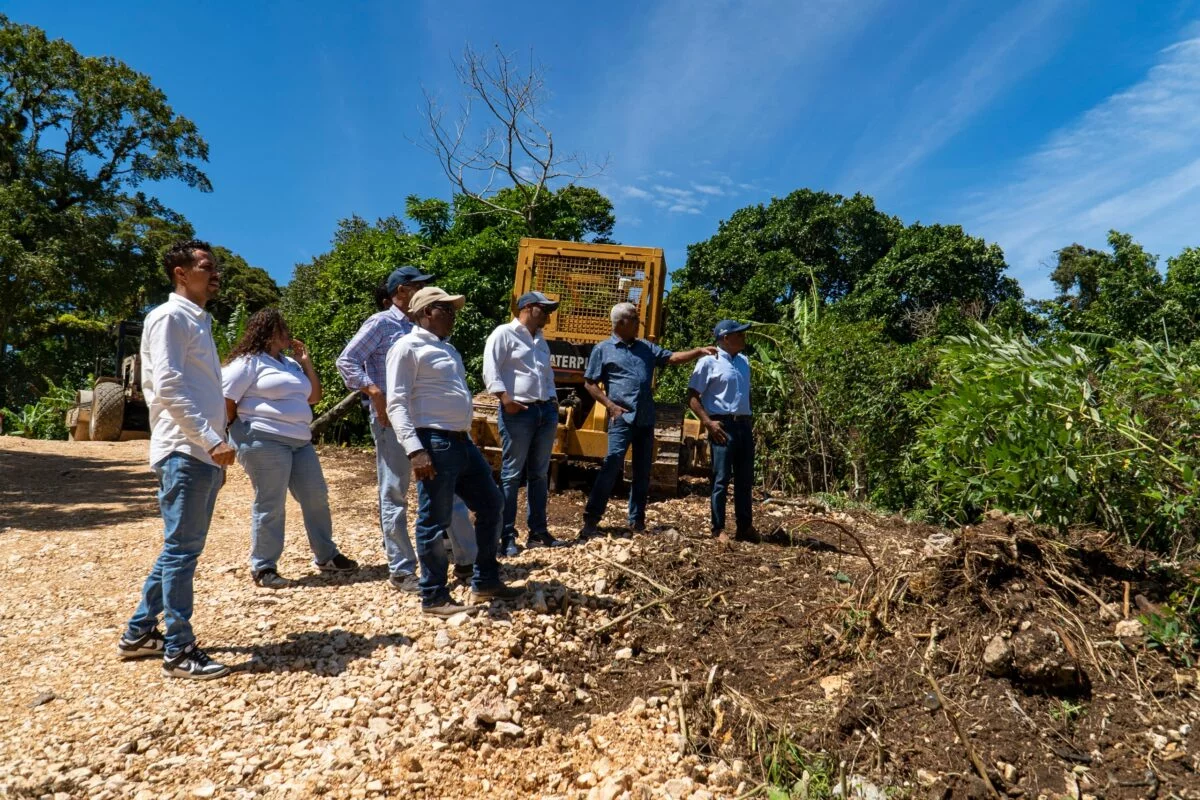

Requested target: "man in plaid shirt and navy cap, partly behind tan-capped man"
[{"left": 337, "top": 266, "right": 475, "bottom": 594}]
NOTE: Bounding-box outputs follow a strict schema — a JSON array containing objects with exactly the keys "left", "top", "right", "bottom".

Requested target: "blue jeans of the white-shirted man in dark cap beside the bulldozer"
[{"left": 500, "top": 403, "right": 558, "bottom": 542}]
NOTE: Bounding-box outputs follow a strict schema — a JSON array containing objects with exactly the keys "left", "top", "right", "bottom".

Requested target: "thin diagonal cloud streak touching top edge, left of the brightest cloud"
[{"left": 838, "top": 0, "right": 1069, "bottom": 193}]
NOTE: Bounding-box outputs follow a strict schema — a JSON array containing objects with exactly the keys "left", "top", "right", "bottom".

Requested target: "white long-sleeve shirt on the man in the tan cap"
[{"left": 386, "top": 326, "right": 472, "bottom": 455}]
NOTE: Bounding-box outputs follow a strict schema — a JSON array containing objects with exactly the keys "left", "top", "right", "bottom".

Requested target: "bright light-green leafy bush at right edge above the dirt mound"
[{"left": 910, "top": 327, "right": 1200, "bottom": 549}]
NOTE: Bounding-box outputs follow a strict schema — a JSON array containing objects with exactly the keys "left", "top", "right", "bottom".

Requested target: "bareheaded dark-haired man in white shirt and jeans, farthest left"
[{"left": 116, "top": 241, "right": 234, "bottom": 680}]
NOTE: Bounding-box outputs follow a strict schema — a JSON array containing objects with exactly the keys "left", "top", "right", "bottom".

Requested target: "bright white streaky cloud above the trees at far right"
[{"left": 966, "top": 26, "right": 1200, "bottom": 296}]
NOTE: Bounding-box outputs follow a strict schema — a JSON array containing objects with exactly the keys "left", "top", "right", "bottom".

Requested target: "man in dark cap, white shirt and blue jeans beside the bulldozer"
[{"left": 484, "top": 291, "right": 560, "bottom": 555}]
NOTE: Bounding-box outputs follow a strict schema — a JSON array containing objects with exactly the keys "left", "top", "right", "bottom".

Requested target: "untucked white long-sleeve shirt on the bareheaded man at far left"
[{"left": 142, "top": 293, "right": 226, "bottom": 467}]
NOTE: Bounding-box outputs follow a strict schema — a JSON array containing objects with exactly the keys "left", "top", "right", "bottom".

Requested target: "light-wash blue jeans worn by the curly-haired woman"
[{"left": 229, "top": 420, "right": 337, "bottom": 575}]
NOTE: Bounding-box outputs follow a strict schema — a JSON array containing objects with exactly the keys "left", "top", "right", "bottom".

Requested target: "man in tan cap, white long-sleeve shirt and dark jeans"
[{"left": 386, "top": 287, "right": 524, "bottom": 618}]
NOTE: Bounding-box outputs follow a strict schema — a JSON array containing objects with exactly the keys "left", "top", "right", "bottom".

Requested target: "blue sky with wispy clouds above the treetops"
[{"left": 9, "top": 0, "right": 1200, "bottom": 296}]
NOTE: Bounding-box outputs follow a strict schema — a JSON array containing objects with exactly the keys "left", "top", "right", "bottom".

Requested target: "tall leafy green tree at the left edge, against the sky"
[{"left": 0, "top": 14, "right": 210, "bottom": 404}]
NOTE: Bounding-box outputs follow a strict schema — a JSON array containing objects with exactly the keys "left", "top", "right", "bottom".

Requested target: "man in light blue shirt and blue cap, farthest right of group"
[{"left": 688, "top": 319, "right": 757, "bottom": 541}]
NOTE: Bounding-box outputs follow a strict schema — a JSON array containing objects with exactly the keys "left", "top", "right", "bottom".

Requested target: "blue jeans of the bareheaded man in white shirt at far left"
[{"left": 125, "top": 452, "right": 224, "bottom": 656}]
